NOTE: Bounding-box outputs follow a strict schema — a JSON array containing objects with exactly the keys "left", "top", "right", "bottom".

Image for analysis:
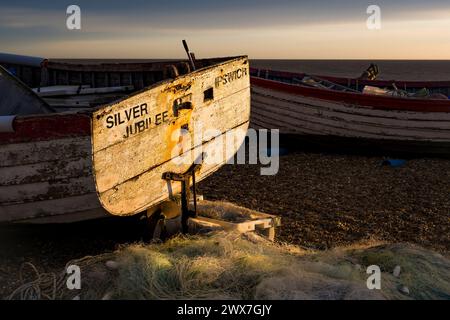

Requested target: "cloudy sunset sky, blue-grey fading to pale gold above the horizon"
[{"left": 0, "top": 0, "right": 450, "bottom": 59}]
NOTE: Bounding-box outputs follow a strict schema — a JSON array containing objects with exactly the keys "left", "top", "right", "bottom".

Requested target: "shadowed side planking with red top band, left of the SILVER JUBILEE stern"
[{"left": 0, "top": 115, "right": 107, "bottom": 222}]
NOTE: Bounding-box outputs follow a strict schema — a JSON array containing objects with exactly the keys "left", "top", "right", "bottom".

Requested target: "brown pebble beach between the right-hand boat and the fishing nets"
[{"left": 198, "top": 153, "right": 450, "bottom": 252}]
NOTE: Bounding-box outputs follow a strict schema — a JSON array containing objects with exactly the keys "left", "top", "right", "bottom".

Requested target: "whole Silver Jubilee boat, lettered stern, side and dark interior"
[{"left": 0, "top": 56, "right": 250, "bottom": 222}]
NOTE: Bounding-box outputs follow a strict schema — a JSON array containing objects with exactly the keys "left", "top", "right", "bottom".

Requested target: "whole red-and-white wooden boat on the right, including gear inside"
[{"left": 251, "top": 69, "right": 450, "bottom": 156}]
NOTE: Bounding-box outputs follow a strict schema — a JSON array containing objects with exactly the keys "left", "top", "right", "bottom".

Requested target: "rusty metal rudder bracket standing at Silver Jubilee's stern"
[{"left": 162, "top": 154, "right": 203, "bottom": 233}]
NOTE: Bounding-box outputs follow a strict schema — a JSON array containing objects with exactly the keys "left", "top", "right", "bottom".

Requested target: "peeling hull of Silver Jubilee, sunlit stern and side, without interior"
[{"left": 0, "top": 57, "right": 250, "bottom": 222}]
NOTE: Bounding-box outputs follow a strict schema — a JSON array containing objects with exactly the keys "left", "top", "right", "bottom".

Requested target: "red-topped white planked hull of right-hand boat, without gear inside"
[{"left": 251, "top": 78, "right": 450, "bottom": 155}]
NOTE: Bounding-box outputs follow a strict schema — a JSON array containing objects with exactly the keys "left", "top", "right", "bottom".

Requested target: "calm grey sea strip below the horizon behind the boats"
[{"left": 55, "top": 59, "right": 450, "bottom": 80}]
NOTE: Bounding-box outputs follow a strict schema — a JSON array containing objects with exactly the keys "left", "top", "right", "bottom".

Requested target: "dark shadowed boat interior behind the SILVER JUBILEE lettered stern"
[{"left": 0, "top": 53, "right": 237, "bottom": 111}]
